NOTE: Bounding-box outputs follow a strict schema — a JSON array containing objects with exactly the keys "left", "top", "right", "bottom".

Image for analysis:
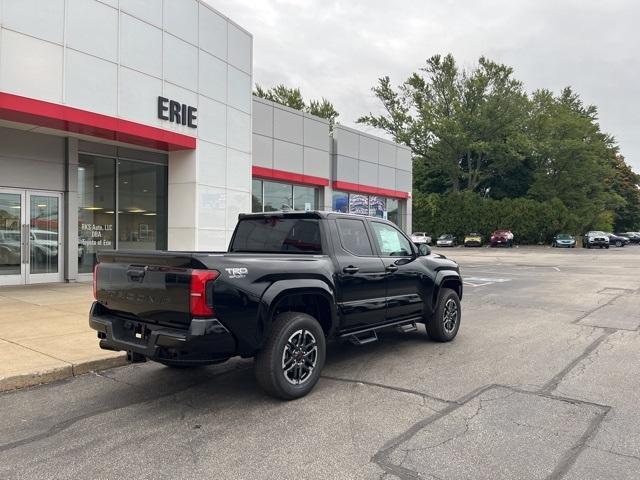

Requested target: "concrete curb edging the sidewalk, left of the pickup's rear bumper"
[{"left": 0, "top": 354, "right": 127, "bottom": 392}]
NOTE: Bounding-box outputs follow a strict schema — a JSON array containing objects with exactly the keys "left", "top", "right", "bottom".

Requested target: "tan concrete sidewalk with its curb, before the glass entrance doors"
[{"left": 0, "top": 283, "right": 126, "bottom": 391}]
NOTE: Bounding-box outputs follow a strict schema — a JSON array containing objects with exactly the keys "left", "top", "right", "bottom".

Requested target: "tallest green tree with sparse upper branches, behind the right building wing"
[{"left": 358, "top": 54, "right": 528, "bottom": 192}]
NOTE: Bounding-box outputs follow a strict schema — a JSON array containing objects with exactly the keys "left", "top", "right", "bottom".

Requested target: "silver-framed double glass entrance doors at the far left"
[{"left": 0, "top": 190, "right": 63, "bottom": 285}]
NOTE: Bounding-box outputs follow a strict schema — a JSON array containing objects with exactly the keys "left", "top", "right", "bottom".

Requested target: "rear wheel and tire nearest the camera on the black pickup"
[{"left": 255, "top": 312, "right": 326, "bottom": 400}]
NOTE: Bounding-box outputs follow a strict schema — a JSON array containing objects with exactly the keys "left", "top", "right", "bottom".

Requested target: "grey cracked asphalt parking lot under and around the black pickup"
[{"left": 0, "top": 246, "right": 640, "bottom": 480}]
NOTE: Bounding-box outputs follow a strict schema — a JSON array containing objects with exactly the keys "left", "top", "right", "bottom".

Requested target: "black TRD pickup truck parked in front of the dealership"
[{"left": 89, "top": 212, "right": 462, "bottom": 399}]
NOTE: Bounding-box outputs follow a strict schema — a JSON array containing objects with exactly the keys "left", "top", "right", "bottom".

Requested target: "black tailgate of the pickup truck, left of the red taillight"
[{"left": 96, "top": 251, "right": 208, "bottom": 327}]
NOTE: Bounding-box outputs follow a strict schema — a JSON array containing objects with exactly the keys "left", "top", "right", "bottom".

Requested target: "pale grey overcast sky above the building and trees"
[{"left": 207, "top": 0, "right": 640, "bottom": 172}]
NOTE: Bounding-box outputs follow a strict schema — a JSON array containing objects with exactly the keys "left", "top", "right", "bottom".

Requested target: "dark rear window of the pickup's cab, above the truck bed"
[{"left": 231, "top": 216, "right": 322, "bottom": 254}]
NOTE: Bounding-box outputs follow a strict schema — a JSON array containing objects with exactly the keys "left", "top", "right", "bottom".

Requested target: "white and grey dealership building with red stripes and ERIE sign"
[{"left": 0, "top": 0, "right": 412, "bottom": 285}]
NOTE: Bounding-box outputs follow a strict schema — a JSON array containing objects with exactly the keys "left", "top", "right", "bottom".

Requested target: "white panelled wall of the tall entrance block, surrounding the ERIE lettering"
[{"left": 0, "top": 0, "right": 253, "bottom": 250}]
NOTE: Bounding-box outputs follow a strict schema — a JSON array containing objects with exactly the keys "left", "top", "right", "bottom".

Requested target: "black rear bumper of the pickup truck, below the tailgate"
[{"left": 89, "top": 302, "right": 236, "bottom": 364}]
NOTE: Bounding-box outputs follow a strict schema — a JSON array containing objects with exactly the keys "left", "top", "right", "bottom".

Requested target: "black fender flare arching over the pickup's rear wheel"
[{"left": 258, "top": 279, "right": 338, "bottom": 338}]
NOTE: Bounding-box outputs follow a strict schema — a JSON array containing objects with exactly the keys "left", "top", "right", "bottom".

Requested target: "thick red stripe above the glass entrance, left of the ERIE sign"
[{"left": 0, "top": 90, "right": 196, "bottom": 151}]
